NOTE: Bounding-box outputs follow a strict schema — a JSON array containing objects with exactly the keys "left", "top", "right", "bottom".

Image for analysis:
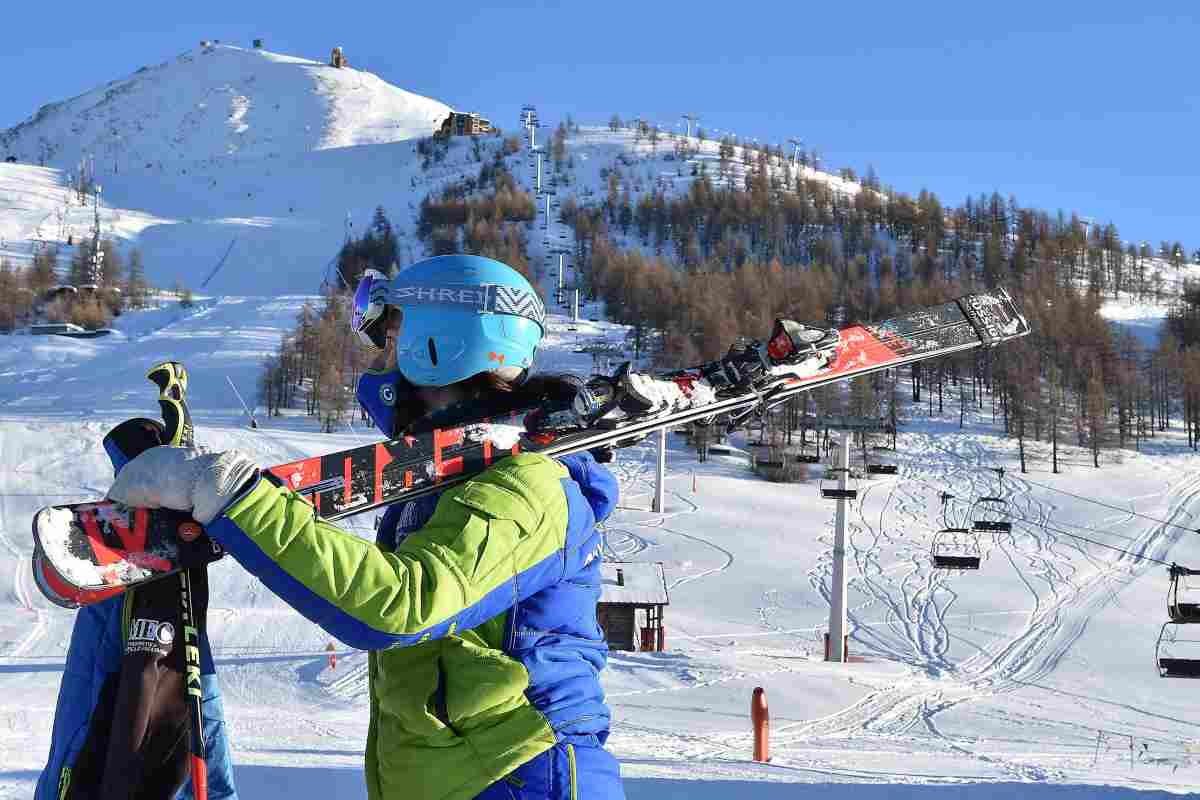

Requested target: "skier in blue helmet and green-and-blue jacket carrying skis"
[{"left": 109, "top": 255, "right": 624, "bottom": 800}]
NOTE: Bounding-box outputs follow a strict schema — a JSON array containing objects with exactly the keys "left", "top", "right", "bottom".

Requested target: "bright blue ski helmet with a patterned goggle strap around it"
[{"left": 374, "top": 255, "right": 546, "bottom": 386}]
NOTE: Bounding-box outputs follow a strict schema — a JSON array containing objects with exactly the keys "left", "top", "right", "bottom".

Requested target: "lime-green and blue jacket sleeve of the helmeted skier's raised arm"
[{"left": 208, "top": 453, "right": 609, "bottom": 650}]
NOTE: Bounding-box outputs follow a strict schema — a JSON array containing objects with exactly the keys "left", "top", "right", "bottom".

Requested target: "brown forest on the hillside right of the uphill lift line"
[{"left": 563, "top": 145, "right": 1200, "bottom": 471}]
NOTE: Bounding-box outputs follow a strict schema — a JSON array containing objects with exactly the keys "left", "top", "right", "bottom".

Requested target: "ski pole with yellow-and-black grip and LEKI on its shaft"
[{"left": 146, "top": 361, "right": 209, "bottom": 800}]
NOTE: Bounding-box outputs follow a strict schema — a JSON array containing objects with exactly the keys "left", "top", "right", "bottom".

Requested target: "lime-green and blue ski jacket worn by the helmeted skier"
[{"left": 208, "top": 453, "right": 623, "bottom": 800}]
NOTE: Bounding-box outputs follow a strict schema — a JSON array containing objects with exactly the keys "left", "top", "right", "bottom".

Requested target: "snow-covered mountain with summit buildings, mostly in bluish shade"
[{"left": 0, "top": 46, "right": 450, "bottom": 294}]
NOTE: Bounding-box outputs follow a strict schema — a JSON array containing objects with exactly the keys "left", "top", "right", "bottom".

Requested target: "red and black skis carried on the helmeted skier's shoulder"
[{"left": 34, "top": 289, "right": 1030, "bottom": 607}]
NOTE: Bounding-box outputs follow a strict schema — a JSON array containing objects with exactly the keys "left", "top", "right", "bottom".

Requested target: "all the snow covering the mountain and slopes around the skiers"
[{"left": 0, "top": 47, "right": 1200, "bottom": 800}]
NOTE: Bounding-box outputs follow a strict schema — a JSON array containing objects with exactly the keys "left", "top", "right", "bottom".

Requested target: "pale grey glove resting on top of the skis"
[{"left": 108, "top": 446, "right": 258, "bottom": 525}]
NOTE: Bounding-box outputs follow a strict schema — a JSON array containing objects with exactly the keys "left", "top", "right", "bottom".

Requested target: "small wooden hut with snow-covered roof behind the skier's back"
[{"left": 596, "top": 561, "right": 671, "bottom": 651}]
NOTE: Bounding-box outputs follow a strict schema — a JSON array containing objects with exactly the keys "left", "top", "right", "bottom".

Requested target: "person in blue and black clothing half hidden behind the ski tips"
[{"left": 34, "top": 420, "right": 238, "bottom": 800}]
